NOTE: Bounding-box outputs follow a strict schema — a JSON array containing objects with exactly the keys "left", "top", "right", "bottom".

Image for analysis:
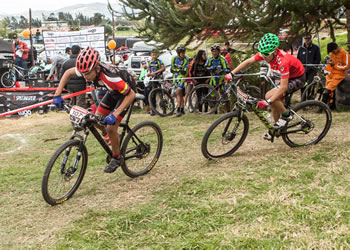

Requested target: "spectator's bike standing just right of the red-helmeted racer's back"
[{"left": 148, "top": 81, "right": 176, "bottom": 117}]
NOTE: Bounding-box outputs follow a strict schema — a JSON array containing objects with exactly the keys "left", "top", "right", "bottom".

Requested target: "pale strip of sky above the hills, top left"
[{"left": 0, "top": 0, "right": 108, "bottom": 14}]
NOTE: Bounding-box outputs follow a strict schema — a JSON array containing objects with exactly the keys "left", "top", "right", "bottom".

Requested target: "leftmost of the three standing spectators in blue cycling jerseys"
[{"left": 145, "top": 50, "right": 165, "bottom": 115}]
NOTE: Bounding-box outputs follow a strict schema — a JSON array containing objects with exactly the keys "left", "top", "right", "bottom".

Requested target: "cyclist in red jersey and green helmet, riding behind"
[{"left": 227, "top": 33, "right": 305, "bottom": 140}]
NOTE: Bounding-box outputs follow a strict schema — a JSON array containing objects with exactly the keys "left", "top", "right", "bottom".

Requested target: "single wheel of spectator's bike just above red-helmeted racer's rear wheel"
[{"left": 148, "top": 88, "right": 175, "bottom": 117}]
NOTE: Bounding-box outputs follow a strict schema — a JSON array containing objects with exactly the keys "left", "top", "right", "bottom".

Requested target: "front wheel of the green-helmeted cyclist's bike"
[{"left": 201, "top": 112, "right": 249, "bottom": 159}]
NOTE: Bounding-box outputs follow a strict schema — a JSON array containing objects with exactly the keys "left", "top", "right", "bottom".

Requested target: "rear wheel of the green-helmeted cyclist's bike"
[{"left": 281, "top": 100, "right": 332, "bottom": 147}]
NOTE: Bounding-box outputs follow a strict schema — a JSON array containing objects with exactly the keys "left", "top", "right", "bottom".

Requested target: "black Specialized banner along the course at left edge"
[{"left": 0, "top": 91, "right": 54, "bottom": 116}]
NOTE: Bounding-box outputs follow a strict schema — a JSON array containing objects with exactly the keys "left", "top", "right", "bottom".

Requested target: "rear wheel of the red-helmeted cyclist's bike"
[{"left": 121, "top": 121, "right": 163, "bottom": 178}]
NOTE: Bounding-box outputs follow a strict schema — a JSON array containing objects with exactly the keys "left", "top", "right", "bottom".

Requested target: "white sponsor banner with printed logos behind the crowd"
[{"left": 43, "top": 26, "right": 106, "bottom": 57}]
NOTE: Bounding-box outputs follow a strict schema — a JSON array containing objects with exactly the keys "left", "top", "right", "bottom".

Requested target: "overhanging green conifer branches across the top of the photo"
[{"left": 121, "top": 0, "right": 349, "bottom": 47}]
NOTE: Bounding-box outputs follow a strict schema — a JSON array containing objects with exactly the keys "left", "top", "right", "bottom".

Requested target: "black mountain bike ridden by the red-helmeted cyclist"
[{"left": 41, "top": 94, "right": 163, "bottom": 206}]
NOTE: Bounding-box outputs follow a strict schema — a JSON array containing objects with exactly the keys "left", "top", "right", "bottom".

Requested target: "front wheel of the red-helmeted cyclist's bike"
[{"left": 41, "top": 140, "right": 88, "bottom": 206}]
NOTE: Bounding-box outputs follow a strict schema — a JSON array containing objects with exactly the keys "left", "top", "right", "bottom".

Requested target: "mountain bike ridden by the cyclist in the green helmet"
[{"left": 201, "top": 79, "right": 332, "bottom": 159}]
